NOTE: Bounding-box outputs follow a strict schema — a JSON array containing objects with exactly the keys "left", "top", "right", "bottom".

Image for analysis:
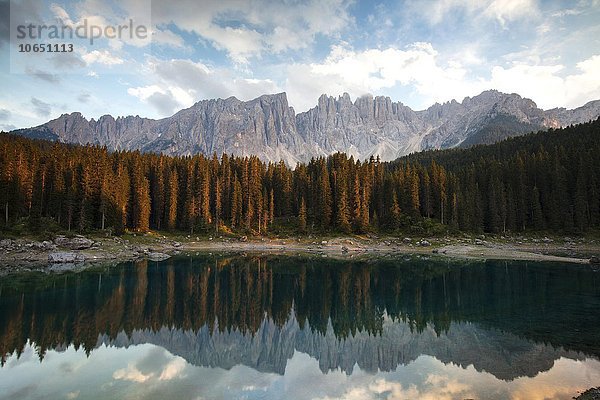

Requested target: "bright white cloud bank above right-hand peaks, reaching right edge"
[{"left": 285, "top": 43, "right": 600, "bottom": 111}]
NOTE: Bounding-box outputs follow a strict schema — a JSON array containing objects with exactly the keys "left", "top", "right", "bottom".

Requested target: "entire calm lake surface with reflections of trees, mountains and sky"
[{"left": 0, "top": 255, "right": 600, "bottom": 399}]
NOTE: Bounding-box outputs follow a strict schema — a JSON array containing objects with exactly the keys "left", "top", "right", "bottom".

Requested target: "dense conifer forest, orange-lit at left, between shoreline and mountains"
[{"left": 0, "top": 121, "right": 600, "bottom": 234}]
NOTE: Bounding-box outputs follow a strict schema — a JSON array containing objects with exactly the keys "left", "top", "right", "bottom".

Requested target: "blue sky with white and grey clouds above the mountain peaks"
[{"left": 0, "top": 0, "right": 600, "bottom": 130}]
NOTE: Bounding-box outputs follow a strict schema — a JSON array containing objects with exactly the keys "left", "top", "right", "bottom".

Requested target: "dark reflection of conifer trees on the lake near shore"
[{"left": 0, "top": 257, "right": 600, "bottom": 361}]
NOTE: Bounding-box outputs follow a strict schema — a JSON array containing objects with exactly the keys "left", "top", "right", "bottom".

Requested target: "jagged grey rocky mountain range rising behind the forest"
[{"left": 11, "top": 90, "right": 600, "bottom": 165}]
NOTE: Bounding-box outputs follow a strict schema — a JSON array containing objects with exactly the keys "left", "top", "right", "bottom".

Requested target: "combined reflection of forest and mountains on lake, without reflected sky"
[{"left": 0, "top": 257, "right": 600, "bottom": 379}]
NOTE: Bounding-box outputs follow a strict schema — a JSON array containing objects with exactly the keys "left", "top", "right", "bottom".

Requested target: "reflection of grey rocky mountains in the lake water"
[{"left": 98, "top": 316, "right": 585, "bottom": 380}]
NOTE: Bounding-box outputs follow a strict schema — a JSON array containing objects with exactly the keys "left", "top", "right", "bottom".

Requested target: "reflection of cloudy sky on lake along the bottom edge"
[{"left": 0, "top": 344, "right": 600, "bottom": 400}]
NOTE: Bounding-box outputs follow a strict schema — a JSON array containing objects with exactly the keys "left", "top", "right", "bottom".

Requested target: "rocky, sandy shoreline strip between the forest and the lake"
[{"left": 0, "top": 234, "right": 600, "bottom": 274}]
